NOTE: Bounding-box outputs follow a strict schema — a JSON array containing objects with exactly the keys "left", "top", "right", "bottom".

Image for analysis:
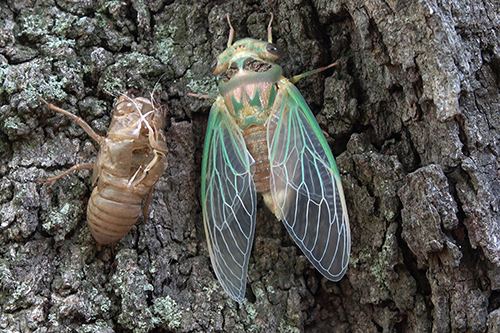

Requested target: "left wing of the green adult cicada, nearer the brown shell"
[{"left": 202, "top": 97, "right": 256, "bottom": 302}]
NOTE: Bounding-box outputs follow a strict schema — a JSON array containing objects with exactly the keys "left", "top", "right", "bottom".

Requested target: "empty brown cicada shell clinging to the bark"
[{"left": 40, "top": 91, "right": 167, "bottom": 244}]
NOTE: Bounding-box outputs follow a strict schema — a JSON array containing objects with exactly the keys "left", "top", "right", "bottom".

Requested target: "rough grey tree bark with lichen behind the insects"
[{"left": 0, "top": 0, "right": 500, "bottom": 333}]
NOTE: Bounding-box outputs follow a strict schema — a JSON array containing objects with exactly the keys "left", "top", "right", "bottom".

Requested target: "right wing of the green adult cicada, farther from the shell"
[{"left": 268, "top": 79, "right": 351, "bottom": 281}]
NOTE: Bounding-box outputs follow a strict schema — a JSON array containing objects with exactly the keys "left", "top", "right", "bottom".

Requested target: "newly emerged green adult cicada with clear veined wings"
[{"left": 201, "top": 15, "right": 351, "bottom": 302}]
